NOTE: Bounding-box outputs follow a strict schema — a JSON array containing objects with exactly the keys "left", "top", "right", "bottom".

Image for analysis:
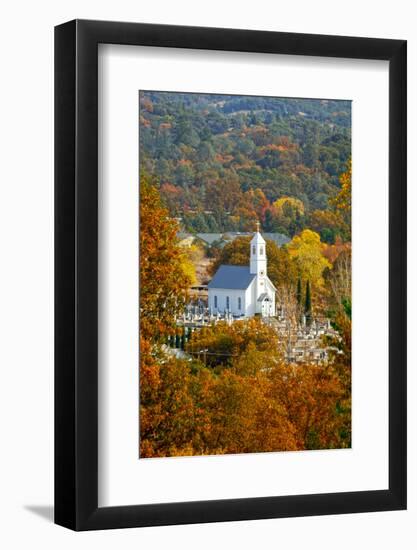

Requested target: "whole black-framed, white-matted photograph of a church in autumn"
[{"left": 55, "top": 20, "right": 406, "bottom": 530}]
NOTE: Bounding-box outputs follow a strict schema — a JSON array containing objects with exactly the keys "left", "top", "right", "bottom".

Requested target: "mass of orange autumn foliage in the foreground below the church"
[{"left": 140, "top": 319, "right": 350, "bottom": 457}]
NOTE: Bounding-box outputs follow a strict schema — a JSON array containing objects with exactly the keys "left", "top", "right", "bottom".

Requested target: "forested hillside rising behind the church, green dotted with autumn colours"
[{"left": 140, "top": 92, "right": 351, "bottom": 243}]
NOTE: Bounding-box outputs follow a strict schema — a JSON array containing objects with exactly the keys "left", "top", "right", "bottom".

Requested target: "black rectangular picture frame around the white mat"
[{"left": 55, "top": 20, "right": 407, "bottom": 531}]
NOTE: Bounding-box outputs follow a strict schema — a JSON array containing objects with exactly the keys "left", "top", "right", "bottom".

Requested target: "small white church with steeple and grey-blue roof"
[{"left": 208, "top": 226, "right": 276, "bottom": 317}]
